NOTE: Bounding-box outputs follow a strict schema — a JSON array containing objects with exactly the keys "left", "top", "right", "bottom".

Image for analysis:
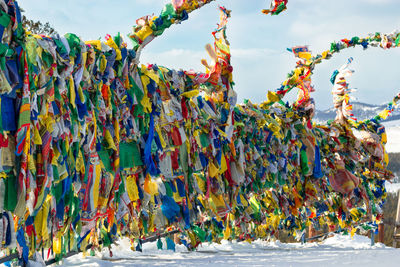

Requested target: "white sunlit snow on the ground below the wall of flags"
[{"left": 57, "top": 235, "right": 400, "bottom": 267}]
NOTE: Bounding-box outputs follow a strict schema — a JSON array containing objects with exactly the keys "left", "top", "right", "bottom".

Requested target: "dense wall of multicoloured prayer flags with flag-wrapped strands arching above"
[{"left": 0, "top": 0, "right": 400, "bottom": 262}]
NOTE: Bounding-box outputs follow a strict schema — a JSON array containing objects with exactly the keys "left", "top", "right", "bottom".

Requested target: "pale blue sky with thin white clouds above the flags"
[{"left": 19, "top": 0, "right": 400, "bottom": 110}]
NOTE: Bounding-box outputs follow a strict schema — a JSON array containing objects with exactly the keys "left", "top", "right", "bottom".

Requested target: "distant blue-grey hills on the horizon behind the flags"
[{"left": 314, "top": 102, "right": 400, "bottom": 123}]
